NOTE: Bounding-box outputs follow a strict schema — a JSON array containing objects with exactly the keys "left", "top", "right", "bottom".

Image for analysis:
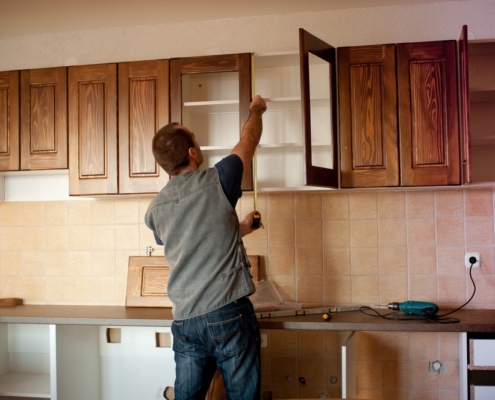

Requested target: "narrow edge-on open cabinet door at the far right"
[{"left": 459, "top": 25, "right": 473, "bottom": 184}]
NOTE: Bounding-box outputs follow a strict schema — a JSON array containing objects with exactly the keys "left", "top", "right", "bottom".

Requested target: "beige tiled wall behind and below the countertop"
[{"left": 0, "top": 188, "right": 495, "bottom": 400}]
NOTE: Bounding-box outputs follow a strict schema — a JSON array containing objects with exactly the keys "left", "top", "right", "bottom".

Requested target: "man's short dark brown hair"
[{"left": 152, "top": 122, "right": 195, "bottom": 176}]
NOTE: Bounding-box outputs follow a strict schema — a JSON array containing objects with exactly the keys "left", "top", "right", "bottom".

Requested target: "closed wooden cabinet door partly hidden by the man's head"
[{"left": 119, "top": 60, "right": 169, "bottom": 194}]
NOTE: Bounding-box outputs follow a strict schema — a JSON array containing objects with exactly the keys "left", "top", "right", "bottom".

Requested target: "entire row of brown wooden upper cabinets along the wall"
[{"left": 0, "top": 27, "right": 495, "bottom": 195}]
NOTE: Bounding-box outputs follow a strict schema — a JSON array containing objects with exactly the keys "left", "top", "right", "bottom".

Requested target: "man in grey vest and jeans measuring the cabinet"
[{"left": 145, "top": 96, "right": 266, "bottom": 400}]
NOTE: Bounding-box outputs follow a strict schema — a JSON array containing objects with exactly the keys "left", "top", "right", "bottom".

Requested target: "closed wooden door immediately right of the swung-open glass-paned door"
[{"left": 338, "top": 44, "right": 399, "bottom": 187}]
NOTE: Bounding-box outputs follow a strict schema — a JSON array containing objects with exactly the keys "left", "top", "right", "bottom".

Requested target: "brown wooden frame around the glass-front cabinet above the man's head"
[{"left": 170, "top": 53, "right": 253, "bottom": 191}]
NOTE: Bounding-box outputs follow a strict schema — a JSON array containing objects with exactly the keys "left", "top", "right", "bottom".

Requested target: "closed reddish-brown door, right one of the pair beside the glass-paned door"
[{"left": 397, "top": 41, "right": 460, "bottom": 186}]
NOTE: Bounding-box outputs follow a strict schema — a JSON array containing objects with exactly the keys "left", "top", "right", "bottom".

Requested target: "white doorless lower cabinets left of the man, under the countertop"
[{"left": 0, "top": 324, "right": 175, "bottom": 400}]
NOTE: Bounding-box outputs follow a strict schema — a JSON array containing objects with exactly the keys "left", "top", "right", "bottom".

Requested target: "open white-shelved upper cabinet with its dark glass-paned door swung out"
[{"left": 254, "top": 29, "right": 338, "bottom": 191}]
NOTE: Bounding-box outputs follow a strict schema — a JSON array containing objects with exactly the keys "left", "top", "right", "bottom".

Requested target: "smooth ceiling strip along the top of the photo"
[{"left": 0, "top": 0, "right": 469, "bottom": 37}]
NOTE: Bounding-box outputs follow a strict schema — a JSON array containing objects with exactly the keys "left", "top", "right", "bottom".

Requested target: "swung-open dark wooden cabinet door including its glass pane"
[{"left": 299, "top": 28, "right": 339, "bottom": 188}]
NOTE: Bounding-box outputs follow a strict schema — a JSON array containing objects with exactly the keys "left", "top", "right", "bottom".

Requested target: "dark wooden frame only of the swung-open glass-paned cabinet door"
[{"left": 299, "top": 28, "right": 339, "bottom": 188}]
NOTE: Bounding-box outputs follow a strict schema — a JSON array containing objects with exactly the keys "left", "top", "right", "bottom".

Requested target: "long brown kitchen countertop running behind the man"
[{"left": 0, "top": 305, "right": 495, "bottom": 332}]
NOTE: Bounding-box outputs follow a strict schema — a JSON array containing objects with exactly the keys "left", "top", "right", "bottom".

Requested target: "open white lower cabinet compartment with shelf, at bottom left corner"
[{"left": 0, "top": 324, "right": 57, "bottom": 400}]
